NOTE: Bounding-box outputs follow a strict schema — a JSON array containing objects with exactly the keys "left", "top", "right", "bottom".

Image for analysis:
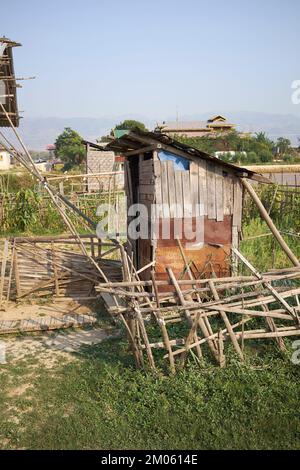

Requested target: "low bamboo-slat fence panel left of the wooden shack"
[{"left": 0, "top": 235, "right": 122, "bottom": 309}]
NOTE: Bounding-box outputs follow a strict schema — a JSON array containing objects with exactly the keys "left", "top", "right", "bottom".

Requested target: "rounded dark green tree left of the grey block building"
[{"left": 55, "top": 127, "right": 85, "bottom": 170}]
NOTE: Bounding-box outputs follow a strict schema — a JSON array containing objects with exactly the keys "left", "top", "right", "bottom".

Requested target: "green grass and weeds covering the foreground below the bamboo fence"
[{"left": 0, "top": 330, "right": 300, "bottom": 450}]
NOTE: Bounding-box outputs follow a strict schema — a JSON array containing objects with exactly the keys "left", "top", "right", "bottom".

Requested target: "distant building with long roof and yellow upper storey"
[{"left": 156, "top": 115, "right": 236, "bottom": 137}]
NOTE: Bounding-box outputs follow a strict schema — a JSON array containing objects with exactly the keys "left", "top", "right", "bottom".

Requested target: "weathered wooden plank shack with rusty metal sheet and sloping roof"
[{"left": 107, "top": 129, "right": 260, "bottom": 279}]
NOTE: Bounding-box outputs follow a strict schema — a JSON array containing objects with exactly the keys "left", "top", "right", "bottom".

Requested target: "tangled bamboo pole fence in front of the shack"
[{"left": 96, "top": 246, "right": 300, "bottom": 373}]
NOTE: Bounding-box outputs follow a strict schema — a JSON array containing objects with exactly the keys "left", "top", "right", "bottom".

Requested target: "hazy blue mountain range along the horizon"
[{"left": 20, "top": 111, "right": 300, "bottom": 150}]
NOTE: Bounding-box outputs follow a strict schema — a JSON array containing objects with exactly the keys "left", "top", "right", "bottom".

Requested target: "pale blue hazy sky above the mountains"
[{"left": 0, "top": 0, "right": 300, "bottom": 119}]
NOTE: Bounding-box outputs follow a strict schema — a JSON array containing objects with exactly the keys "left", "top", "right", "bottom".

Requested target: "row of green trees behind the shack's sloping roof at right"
[{"left": 175, "top": 131, "right": 300, "bottom": 165}]
